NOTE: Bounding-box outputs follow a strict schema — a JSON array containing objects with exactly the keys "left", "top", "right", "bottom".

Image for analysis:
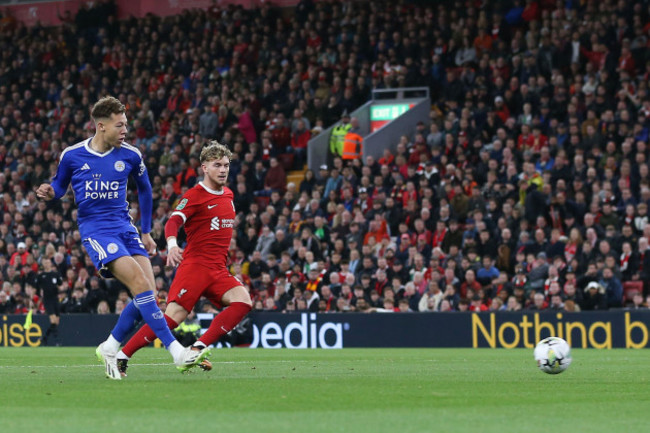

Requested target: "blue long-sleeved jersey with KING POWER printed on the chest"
[{"left": 52, "top": 138, "right": 153, "bottom": 238}]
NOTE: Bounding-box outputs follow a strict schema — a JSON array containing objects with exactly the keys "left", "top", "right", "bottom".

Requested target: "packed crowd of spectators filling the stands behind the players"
[{"left": 0, "top": 0, "right": 650, "bottom": 313}]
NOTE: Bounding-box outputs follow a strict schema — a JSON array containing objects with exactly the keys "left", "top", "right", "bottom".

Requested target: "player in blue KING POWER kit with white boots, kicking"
[{"left": 36, "top": 96, "right": 209, "bottom": 380}]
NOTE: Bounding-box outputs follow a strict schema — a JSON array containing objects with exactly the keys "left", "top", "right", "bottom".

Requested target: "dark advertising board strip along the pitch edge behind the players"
[{"left": 0, "top": 310, "right": 650, "bottom": 349}]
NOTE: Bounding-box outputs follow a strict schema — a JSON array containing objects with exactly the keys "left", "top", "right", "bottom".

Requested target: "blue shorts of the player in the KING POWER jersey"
[{"left": 82, "top": 227, "right": 149, "bottom": 278}]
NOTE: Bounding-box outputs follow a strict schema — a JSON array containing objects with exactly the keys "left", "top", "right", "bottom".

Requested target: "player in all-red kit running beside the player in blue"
[{"left": 117, "top": 141, "right": 252, "bottom": 376}]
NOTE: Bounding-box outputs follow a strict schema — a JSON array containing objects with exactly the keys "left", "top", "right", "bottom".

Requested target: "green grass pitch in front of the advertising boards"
[{"left": 0, "top": 348, "right": 650, "bottom": 433}]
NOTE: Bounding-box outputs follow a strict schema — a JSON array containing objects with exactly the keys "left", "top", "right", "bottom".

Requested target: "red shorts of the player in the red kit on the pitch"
[{"left": 167, "top": 263, "right": 243, "bottom": 311}]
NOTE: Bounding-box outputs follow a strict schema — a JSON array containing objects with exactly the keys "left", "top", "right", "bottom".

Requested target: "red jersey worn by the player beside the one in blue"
[{"left": 172, "top": 182, "right": 235, "bottom": 268}]
